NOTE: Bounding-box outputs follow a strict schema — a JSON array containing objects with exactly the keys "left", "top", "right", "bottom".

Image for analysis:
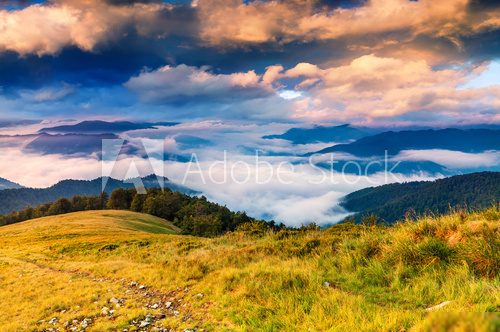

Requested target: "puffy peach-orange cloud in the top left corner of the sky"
[{"left": 0, "top": 0, "right": 192, "bottom": 56}]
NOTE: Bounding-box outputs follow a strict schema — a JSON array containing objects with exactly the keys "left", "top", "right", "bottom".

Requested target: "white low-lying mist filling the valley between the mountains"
[{"left": 0, "top": 121, "right": 492, "bottom": 225}]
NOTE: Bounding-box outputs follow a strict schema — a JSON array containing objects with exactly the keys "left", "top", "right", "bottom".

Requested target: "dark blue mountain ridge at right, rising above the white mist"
[{"left": 316, "top": 128, "right": 500, "bottom": 157}]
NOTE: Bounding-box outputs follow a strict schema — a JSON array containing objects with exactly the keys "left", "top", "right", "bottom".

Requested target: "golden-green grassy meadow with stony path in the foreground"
[{"left": 0, "top": 208, "right": 500, "bottom": 331}]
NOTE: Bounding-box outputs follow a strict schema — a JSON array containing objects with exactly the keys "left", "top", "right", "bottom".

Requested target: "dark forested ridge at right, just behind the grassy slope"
[{"left": 341, "top": 172, "right": 500, "bottom": 223}]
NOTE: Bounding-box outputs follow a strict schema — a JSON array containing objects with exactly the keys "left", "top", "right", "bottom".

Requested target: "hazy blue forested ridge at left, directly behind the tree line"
[{"left": 0, "top": 175, "right": 197, "bottom": 214}]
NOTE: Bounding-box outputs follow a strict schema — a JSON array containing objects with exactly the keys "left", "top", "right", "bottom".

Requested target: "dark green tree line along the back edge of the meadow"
[{"left": 0, "top": 189, "right": 284, "bottom": 237}]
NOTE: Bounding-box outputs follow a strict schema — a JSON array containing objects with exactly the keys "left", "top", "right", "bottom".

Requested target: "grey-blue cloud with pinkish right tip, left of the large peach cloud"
[{"left": 125, "top": 65, "right": 273, "bottom": 103}]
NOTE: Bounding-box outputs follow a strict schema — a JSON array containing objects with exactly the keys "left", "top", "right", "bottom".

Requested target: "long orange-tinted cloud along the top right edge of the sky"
[{"left": 198, "top": 0, "right": 500, "bottom": 52}]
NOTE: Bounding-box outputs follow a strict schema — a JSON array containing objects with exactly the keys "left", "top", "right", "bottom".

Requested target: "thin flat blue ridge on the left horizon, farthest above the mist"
[{"left": 39, "top": 120, "right": 179, "bottom": 134}]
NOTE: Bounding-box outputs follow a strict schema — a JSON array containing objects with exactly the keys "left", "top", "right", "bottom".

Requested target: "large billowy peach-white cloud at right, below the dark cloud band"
[{"left": 268, "top": 54, "right": 500, "bottom": 124}]
